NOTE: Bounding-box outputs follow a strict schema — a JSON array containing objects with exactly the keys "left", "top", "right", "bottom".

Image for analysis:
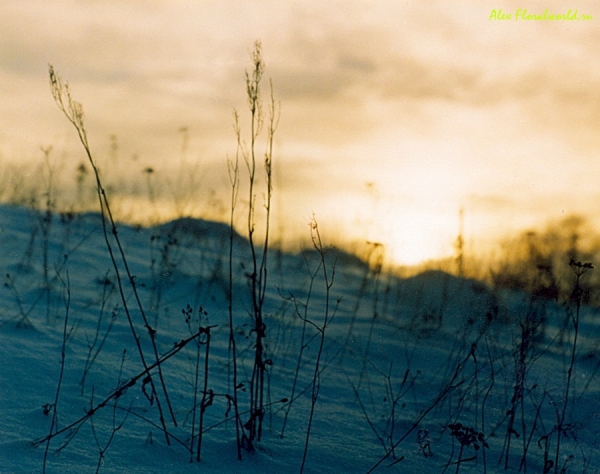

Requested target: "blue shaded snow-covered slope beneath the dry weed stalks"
[{"left": 0, "top": 206, "right": 600, "bottom": 474}]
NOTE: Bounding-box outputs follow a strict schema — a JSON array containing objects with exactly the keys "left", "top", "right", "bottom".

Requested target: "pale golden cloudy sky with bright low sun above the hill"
[{"left": 0, "top": 0, "right": 600, "bottom": 263}]
